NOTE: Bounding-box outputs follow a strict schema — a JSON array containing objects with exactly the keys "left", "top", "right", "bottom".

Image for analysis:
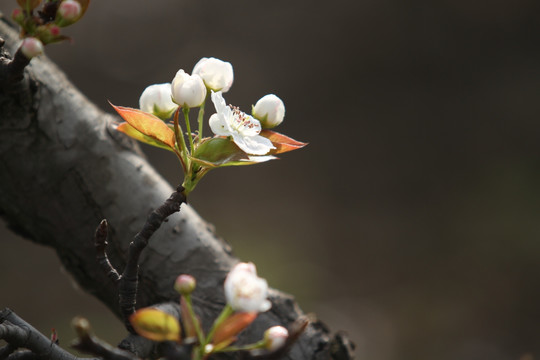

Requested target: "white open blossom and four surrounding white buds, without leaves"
[{"left": 139, "top": 57, "right": 285, "bottom": 155}]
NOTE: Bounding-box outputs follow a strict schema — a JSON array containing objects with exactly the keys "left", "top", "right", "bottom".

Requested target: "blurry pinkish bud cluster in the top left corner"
[{"left": 11, "top": 0, "right": 90, "bottom": 59}]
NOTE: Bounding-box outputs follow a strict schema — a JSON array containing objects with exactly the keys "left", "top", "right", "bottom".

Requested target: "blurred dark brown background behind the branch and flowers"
[{"left": 0, "top": 0, "right": 540, "bottom": 360}]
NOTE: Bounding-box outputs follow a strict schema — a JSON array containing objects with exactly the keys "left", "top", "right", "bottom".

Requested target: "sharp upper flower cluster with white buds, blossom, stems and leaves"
[{"left": 113, "top": 57, "right": 306, "bottom": 195}]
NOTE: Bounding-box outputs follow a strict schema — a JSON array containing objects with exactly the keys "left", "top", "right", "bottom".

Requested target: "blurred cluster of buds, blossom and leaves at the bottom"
[{"left": 130, "top": 263, "right": 296, "bottom": 360}]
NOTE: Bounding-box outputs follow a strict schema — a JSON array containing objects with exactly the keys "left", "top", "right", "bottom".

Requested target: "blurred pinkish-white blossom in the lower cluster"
[{"left": 224, "top": 263, "right": 272, "bottom": 312}]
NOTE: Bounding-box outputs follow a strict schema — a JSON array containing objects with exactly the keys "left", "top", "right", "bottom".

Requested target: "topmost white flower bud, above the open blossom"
[{"left": 193, "top": 58, "right": 234, "bottom": 93}]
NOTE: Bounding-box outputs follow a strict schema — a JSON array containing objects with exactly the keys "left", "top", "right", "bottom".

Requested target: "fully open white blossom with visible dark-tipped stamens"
[{"left": 210, "top": 91, "right": 275, "bottom": 155}]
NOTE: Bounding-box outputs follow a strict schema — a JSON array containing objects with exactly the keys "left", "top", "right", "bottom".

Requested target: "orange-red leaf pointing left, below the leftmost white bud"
[{"left": 111, "top": 104, "right": 175, "bottom": 149}]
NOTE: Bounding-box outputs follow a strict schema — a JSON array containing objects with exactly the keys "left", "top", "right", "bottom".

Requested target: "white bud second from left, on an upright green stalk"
[{"left": 171, "top": 70, "right": 206, "bottom": 108}]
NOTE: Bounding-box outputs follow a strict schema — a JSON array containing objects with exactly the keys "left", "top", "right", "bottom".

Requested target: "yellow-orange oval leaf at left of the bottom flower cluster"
[{"left": 129, "top": 308, "right": 180, "bottom": 341}]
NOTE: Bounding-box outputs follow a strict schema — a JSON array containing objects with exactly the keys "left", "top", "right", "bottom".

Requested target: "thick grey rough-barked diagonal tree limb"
[{"left": 0, "top": 14, "right": 352, "bottom": 359}]
